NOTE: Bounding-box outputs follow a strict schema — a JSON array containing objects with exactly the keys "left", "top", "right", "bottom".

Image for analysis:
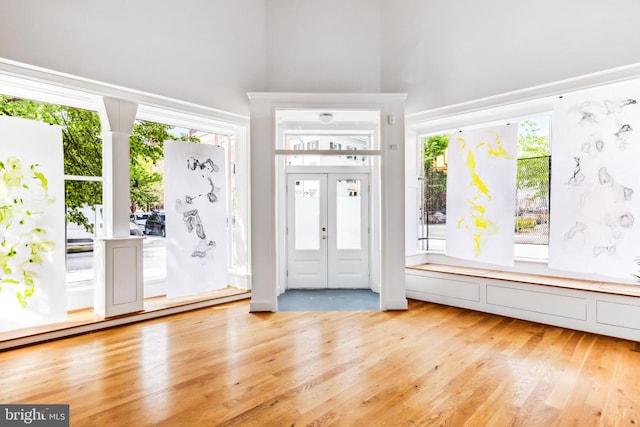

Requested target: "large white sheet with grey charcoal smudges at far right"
[{"left": 549, "top": 82, "right": 640, "bottom": 282}]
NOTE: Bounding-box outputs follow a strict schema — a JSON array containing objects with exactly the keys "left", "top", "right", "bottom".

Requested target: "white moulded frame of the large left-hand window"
[{"left": 0, "top": 58, "right": 251, "bottom": 310}]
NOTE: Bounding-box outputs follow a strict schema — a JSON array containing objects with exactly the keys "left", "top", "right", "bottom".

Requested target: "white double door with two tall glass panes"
[{"left": 287, "top": 173, "right": 370, "bottom": 288}]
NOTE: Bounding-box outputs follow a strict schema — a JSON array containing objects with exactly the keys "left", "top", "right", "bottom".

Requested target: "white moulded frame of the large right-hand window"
[{"left": 405, "top": 63, "right": 640, "bottom": 281}]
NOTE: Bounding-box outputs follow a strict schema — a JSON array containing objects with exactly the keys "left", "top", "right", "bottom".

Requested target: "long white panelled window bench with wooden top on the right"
[{"left": 405, "top": 264, "right": 640, "bottom": 341}]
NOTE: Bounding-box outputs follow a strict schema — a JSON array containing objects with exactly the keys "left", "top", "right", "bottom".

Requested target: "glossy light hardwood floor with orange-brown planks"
[{"left": 0, "top": 300, "right": 640, "bottom": 426}]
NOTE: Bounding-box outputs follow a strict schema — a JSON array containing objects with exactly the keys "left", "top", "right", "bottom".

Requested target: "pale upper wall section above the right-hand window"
[{"left": 381, "top": 0, "right": 640, "bottom": 113}]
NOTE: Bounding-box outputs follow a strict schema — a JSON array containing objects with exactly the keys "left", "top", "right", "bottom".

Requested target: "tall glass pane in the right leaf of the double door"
[{"left": 336, "top": 179, "right": 362, "bottom": 249}]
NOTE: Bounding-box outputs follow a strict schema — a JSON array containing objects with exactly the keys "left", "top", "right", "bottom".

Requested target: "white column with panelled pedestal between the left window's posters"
[{"left": 94, "top": 97, "right": 144, "bottom": 317}]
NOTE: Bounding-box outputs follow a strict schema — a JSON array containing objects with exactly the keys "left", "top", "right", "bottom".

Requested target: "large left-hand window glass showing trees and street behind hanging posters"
[{"left": 0, "top": 95, "right": 238, "bottom": 309}]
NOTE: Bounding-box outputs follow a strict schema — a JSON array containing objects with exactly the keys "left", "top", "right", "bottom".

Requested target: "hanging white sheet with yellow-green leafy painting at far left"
[{"left": 0, "top": 116, "right": 67, "bottom": 331}]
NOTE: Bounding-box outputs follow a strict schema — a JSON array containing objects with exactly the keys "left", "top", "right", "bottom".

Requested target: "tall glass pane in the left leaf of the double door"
[{"left": 294, "top": 179, "right": 320, "bottom": 250}]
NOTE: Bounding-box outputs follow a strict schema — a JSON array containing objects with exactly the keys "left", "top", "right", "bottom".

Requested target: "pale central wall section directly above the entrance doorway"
[{"left": 265, "top": 0, "right": 381, "bottom": 92}]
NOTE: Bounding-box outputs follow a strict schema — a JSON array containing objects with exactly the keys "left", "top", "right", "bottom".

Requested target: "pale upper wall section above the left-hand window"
[{"left": 0, "top": 0, "right": 265, "bottom": 114}]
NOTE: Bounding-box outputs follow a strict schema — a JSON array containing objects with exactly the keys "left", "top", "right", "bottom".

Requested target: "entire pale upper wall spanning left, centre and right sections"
[{"left": 0, "top": 0, "right": 640, "bottom": 114}]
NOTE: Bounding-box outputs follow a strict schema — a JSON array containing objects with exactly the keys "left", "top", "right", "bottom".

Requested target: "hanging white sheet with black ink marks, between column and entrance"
[{"left": 164, "top": 141, "right": 227, "bottom": 298}]
